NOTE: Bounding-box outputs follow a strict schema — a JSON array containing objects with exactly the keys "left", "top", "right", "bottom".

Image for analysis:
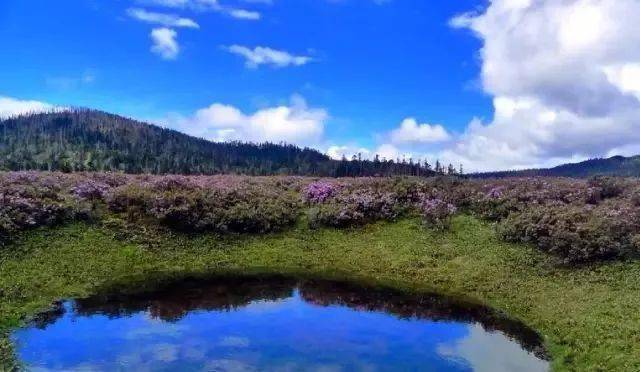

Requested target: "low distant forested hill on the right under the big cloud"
[{"left": 472, "top": 155, "right": 640, "bottom": 178}]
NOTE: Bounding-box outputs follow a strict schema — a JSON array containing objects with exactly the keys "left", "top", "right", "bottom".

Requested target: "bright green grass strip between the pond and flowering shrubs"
[{"left": 0, "top": 216, "right": 640, "bottom": 371}]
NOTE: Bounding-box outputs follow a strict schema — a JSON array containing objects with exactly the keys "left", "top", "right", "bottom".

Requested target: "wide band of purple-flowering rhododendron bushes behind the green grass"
[{"left": 0, "top": 172, "right": 640, "bottom": 263}]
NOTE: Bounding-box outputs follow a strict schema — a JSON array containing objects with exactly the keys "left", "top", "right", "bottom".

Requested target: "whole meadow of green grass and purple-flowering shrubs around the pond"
[{"left": 0, "top": 172, "right": 640, "bottom": 370}]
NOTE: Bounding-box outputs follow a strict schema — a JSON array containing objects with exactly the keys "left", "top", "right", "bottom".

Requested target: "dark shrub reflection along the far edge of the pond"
[{"left": 34, "top": 276, "right": 548, "bottom": 359}]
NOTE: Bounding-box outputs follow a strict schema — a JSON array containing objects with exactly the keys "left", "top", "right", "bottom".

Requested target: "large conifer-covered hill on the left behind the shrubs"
[{"left": 0, "top": 110, "right": 440, "bottom": 177}]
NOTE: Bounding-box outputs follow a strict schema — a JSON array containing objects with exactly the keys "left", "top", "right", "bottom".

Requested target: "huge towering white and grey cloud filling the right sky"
[{"left": 442, "top": 0, "right": 640, "bottom": 170}]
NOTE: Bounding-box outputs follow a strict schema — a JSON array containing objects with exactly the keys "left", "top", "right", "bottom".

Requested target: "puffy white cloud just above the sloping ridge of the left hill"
[{"left": 165, "top": 97, "right": 328, "bottom": 146}]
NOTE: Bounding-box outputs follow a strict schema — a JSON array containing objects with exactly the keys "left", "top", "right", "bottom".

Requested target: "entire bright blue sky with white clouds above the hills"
[{"left": 0, "top": 0, "right": 640, "bottom": 169}]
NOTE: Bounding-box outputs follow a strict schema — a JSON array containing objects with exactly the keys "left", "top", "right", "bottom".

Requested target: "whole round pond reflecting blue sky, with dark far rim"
[{"left": 12, "top": 276, "right": 549, "bottom": 372}]
